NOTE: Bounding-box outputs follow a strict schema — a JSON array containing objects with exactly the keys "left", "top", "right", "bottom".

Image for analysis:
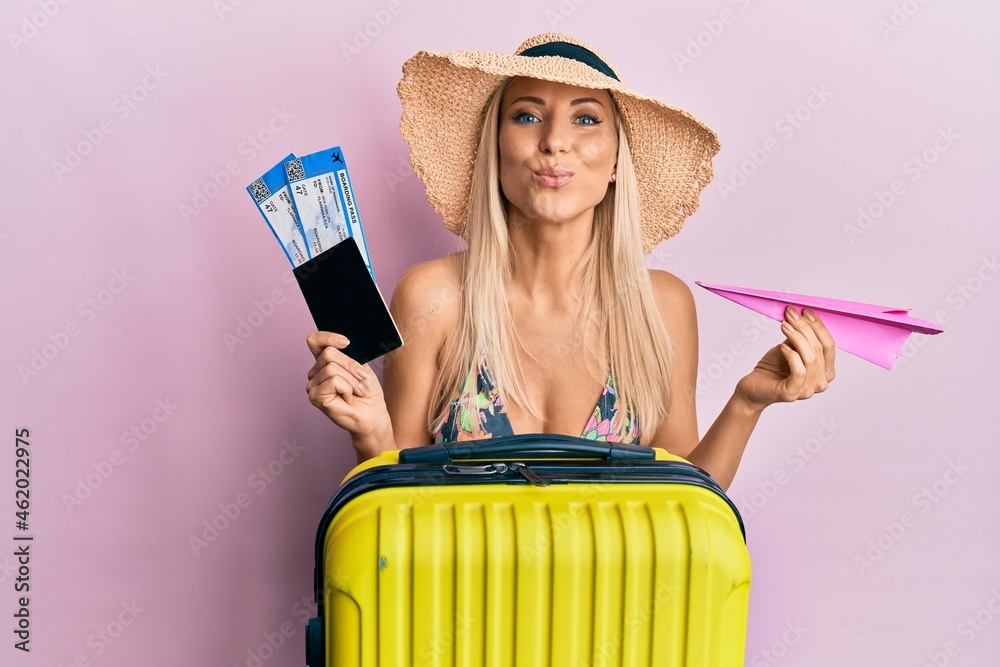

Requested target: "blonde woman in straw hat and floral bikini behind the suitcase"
[{"left": 306, "top": 33, "right": 835, "bottom": 488}]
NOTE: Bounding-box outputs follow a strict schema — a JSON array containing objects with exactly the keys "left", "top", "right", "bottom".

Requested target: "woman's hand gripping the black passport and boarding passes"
[{"left": 306, "top": 331, "right": 391, "bottom": 447}]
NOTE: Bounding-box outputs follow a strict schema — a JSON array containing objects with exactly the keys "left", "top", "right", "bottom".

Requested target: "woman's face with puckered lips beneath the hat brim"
[{"left": 499, "top": 78, "right": 618, "bottom": 230}]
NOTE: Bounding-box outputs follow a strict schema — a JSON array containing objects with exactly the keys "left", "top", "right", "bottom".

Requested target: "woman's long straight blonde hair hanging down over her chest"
[{"left": 427, "top": 79, "right": 673, "bottom": 440}]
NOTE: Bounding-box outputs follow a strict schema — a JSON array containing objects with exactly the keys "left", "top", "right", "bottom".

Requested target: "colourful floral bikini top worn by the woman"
[{"left": 434, "top": 358, "right": 639, "bottom": 444}]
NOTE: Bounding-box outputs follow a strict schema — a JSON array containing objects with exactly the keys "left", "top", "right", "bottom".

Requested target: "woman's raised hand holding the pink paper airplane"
[{"left": 736, "top": 307, "right": 836, "bottom": 410}]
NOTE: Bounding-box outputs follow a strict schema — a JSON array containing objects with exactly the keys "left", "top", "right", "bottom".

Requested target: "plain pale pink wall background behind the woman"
[{"left": 0, "top": 0, "right": 1000, "bottom": 667}]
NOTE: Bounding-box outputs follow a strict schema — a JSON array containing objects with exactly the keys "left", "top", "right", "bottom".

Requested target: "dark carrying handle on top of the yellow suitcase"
[{"left": 399, "top": 433, "right": 656, "bottom": 463}]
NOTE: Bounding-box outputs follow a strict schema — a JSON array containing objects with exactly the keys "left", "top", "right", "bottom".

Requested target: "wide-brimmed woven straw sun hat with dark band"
[{"left": 397, "top": 33, "right": 719, "bottom": 253}]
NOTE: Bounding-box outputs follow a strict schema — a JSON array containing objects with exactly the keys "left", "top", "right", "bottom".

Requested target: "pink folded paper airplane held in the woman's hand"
[{"left": 695, "top": 280, "right": 944, "bottom": 369}]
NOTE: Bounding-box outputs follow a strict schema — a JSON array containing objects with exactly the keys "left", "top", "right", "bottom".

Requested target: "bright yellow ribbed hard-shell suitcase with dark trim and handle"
[{"left": 306, "top": 435, "right": 750, "bottom": 667}]
